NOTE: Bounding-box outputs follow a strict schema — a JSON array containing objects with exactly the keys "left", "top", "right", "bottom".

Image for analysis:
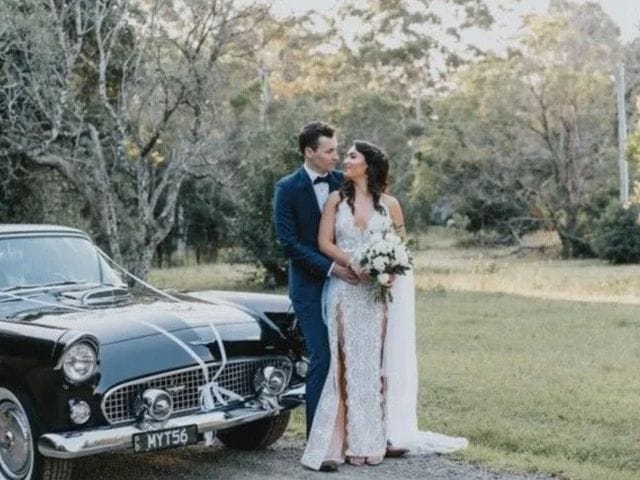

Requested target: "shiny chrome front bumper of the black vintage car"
[{"left": 38, "top": 386, "right": 305, "bottom": 459}]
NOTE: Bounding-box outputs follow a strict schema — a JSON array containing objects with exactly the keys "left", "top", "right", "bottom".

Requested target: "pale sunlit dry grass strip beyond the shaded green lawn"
[{"left": 415, "top": 227, "right": 640, "bottom": 304}]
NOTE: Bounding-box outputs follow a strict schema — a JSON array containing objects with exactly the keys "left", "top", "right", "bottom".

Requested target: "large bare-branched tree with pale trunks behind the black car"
[{"left": 0, "top": 0, "right": 266, "bottom": 278}]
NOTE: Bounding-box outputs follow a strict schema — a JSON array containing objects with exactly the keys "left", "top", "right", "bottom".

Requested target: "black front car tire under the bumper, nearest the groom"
[{"left": 218, "top": 411, "right": 291, "bottom": 450}]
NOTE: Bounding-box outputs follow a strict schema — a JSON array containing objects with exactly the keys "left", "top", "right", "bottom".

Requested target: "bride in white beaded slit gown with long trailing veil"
[{"left": 302, "top": 141, "right": 468, "bottom": 470}]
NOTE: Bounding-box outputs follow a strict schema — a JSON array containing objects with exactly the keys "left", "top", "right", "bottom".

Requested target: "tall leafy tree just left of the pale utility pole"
[{"left": 520, "top": 1, "right": 620, "bottom": 256}]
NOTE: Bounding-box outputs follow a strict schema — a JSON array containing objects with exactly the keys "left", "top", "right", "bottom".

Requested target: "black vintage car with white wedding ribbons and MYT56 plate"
[{"left": 0, "top": 225, "right": 306, "bottom": 480}]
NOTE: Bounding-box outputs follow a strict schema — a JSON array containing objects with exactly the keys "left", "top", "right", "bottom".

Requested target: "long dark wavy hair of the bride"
[{"left": 340, "top": 140, "right": 389, "bottom": 215}]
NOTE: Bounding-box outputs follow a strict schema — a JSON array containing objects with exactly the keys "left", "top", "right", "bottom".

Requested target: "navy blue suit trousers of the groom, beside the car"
[{"left": 293, "top": 298, "right": 331, "bottom": 437}]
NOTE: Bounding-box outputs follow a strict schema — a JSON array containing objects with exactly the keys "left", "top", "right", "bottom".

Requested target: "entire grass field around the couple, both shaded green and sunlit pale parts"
[{"left": 151, "top": 230, "right": 640, "bottom": 480}]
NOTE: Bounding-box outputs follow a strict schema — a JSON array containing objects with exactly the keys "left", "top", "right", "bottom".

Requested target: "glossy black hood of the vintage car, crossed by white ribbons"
[{"left": 31, "top": 302, "right": 286, "bottom": 392}]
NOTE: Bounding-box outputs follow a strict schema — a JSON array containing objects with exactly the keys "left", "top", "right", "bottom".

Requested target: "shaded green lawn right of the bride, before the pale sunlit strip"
[{"left": 417, "top": 291, "right": 640, "bottom": 480}]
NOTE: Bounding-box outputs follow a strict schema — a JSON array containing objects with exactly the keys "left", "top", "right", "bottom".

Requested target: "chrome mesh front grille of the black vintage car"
[{"left": 102, "top": 357, "right": 292, "bottom": 424}]
